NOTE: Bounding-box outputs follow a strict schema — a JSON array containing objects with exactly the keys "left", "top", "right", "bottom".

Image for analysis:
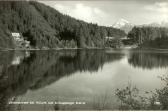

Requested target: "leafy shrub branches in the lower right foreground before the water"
[{"left": 116, "top": 77, "right": 168, "bottom": 110}]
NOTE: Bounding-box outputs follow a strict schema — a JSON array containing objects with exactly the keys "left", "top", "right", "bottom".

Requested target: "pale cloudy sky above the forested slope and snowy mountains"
[{"left": 41, "top": 0, "right": 168, "bottom": 26}]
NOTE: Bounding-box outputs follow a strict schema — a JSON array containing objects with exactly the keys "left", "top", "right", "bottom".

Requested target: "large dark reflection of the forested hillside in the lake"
[{"left": 0, "top": 50, "right": 123, "bottom": 110}]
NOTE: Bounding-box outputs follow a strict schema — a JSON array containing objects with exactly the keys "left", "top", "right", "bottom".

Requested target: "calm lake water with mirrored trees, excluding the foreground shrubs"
[{"left": 0, "top": 50, "right": 168, "bottom": 111}]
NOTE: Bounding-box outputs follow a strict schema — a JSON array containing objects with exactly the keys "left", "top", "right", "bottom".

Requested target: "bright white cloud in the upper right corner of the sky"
[{"left": 144, "top": 2, "right": 168, "bottom": 21}]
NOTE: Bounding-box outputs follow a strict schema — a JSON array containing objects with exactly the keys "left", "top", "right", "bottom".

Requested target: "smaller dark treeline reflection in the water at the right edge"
[{"left": 128, "top": 51, "right": 168, "bottom": 69}]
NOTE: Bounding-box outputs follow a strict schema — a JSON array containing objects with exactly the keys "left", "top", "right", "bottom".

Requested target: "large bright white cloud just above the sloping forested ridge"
[{"left": 54, "top": 3, "right": 108, "bottom": 25}]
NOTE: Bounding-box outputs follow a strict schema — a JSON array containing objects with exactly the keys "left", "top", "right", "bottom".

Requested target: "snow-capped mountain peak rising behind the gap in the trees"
[{"left": 113, "top": 19, "right": 134, "bottom": 33}]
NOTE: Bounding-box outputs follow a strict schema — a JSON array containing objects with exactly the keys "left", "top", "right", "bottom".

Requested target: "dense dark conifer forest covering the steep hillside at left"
[{"left": 0, "top": 1, "right": 125, "bottom": 48}]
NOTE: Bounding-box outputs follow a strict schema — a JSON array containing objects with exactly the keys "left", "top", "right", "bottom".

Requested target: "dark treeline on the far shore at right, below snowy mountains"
[{"left": 128, "top": 27, "right": 168, "bottom": 48}]
